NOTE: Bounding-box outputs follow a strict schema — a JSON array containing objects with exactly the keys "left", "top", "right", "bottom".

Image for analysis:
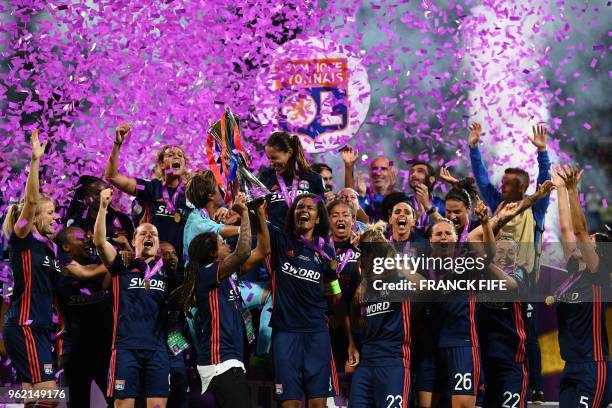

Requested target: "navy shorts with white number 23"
[{"left": 349, "top": 366, "right": 410, "bottom": 408}]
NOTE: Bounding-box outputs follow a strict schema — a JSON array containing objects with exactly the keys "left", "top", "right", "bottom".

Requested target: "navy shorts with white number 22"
[{"left": 482, "top": 358, "right": 529, "bottom": 408}]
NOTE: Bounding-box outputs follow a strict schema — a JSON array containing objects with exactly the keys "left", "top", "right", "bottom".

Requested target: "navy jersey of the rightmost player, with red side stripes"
[{"left": 557, "top": 262, "right": 610, "bottom": 363}]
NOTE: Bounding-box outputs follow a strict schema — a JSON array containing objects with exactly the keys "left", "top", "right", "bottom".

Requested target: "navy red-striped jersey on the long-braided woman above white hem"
[{"left": 196, "top": 261, "right": 244, "bottom": 365}]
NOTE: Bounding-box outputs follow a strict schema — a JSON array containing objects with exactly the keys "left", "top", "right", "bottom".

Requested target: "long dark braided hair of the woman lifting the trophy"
[{"left": 170, "top": 232, "right": 218, "bottom": 312}]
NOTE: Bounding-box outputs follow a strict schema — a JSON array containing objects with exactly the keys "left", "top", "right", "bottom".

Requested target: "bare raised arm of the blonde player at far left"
[{"left": 13, "top": 129, "right": 47, "bottom": 238}]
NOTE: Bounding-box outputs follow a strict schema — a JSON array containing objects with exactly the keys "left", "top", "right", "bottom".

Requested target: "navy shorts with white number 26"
[{"left": 434, "top": 347, "right": 480, "bottom": 395}]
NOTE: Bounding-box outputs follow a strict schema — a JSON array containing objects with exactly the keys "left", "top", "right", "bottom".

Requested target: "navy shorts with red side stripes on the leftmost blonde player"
[{"left": 2, "top": 326, "right": 55, "bottom": 384}]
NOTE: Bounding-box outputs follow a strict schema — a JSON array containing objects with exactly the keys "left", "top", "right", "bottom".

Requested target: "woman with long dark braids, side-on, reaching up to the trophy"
[{"left": 171, "top": 193, "right": 270, "bottom": 408}]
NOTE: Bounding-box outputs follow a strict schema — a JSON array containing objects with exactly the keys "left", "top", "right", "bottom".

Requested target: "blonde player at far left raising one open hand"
[{"left": 2, "top": 130, "right": 61, "bottom": 407}]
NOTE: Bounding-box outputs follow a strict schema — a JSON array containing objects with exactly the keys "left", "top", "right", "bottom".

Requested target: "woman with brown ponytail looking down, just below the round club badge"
[{"left": 259, "top": 132, "right": 325, "bottom": 230}]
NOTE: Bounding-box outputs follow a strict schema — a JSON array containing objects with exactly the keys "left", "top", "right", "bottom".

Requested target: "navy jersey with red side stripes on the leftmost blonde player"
[{"left": 4, "top": 232, "right": 62, "bottom": 329}]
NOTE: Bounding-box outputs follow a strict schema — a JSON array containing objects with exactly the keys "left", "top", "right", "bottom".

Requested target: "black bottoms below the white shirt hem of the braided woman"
[{"left": 208, "top": 367, "right": 251, "bottom": 408}]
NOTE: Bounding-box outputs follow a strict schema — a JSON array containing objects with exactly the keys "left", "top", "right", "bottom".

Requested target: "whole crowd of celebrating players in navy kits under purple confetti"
[{"left": 2, "top": 123, "right": 612, "bottom": 408}]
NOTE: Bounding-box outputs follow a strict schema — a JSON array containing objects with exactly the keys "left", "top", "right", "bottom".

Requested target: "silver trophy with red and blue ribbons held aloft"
[{"left": 206, "top": 108, "right": 271, "bottom": 209}]
